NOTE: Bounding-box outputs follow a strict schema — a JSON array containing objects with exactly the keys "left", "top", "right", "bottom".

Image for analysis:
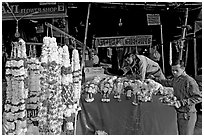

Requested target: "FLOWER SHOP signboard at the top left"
[{"left": 2, "top": 2, "right": 67, "bottom": 20}]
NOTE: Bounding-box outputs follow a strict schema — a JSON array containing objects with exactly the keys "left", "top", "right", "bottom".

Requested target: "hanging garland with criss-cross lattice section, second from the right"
[{"left": 62, "top": 45, "right": 75, "bottom": 135}]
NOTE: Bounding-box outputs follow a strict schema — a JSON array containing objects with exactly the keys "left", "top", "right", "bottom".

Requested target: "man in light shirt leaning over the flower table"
[{"left": 121, "top": 53, "right": 166, "bottom": 81}]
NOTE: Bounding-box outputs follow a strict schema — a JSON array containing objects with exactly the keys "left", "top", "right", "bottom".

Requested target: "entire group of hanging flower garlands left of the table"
[{"left": 2, "top": 37, "right": 82, "bottom": 135}]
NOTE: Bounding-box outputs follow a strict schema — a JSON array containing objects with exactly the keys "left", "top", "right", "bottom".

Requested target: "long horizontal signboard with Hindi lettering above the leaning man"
[{"left": 95, "top": 35, "right": 152, "bottom": 47}]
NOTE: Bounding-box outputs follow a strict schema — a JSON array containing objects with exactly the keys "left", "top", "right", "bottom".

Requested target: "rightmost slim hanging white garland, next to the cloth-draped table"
[{"left": 69, "top": 49, "right": 82, "bottom": 133}]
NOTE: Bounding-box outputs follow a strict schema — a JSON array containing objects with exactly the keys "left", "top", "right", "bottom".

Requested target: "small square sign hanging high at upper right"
[{"left": 147, "top": 14, "right": 161, "bottom": 25}]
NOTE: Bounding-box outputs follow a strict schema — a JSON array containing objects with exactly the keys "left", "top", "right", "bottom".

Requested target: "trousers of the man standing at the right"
[{"left": 177, "top": 112, "right": 197, "bottom": 135}]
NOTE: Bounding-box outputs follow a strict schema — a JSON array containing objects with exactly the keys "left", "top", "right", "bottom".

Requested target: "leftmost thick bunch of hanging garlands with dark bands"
[{"left": 3, "top": 39, "right": 28, "bottom": 135}]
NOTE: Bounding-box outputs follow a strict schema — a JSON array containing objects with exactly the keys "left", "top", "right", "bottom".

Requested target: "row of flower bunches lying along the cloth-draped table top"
[{"left": 82, "top": 76, "right": 176, "bottom": 105}]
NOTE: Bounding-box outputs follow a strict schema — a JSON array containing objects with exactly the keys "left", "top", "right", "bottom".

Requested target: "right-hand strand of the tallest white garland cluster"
[{"left": 48, "top": 37, "right": 63, "bottom": 135}]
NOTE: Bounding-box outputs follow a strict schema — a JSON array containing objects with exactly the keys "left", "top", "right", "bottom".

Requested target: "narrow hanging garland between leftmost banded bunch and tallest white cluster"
[{"left": 26, "top": 45, "right": 40, "bottom": 126}]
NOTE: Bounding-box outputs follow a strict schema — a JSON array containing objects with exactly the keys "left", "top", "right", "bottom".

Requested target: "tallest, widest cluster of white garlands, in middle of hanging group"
[{"left": 39, "top": 37, "right": 64, "bottom": 135}]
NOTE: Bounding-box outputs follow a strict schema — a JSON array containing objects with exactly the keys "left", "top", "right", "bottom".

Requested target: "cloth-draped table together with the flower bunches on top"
[{"left": 77, "top": 76, "right": 177, "bottom": 135}]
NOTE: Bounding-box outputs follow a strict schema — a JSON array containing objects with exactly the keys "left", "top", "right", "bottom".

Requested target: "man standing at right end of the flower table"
[{"left": 151, "top": 61, "right": 202, "bottom": 135}]
